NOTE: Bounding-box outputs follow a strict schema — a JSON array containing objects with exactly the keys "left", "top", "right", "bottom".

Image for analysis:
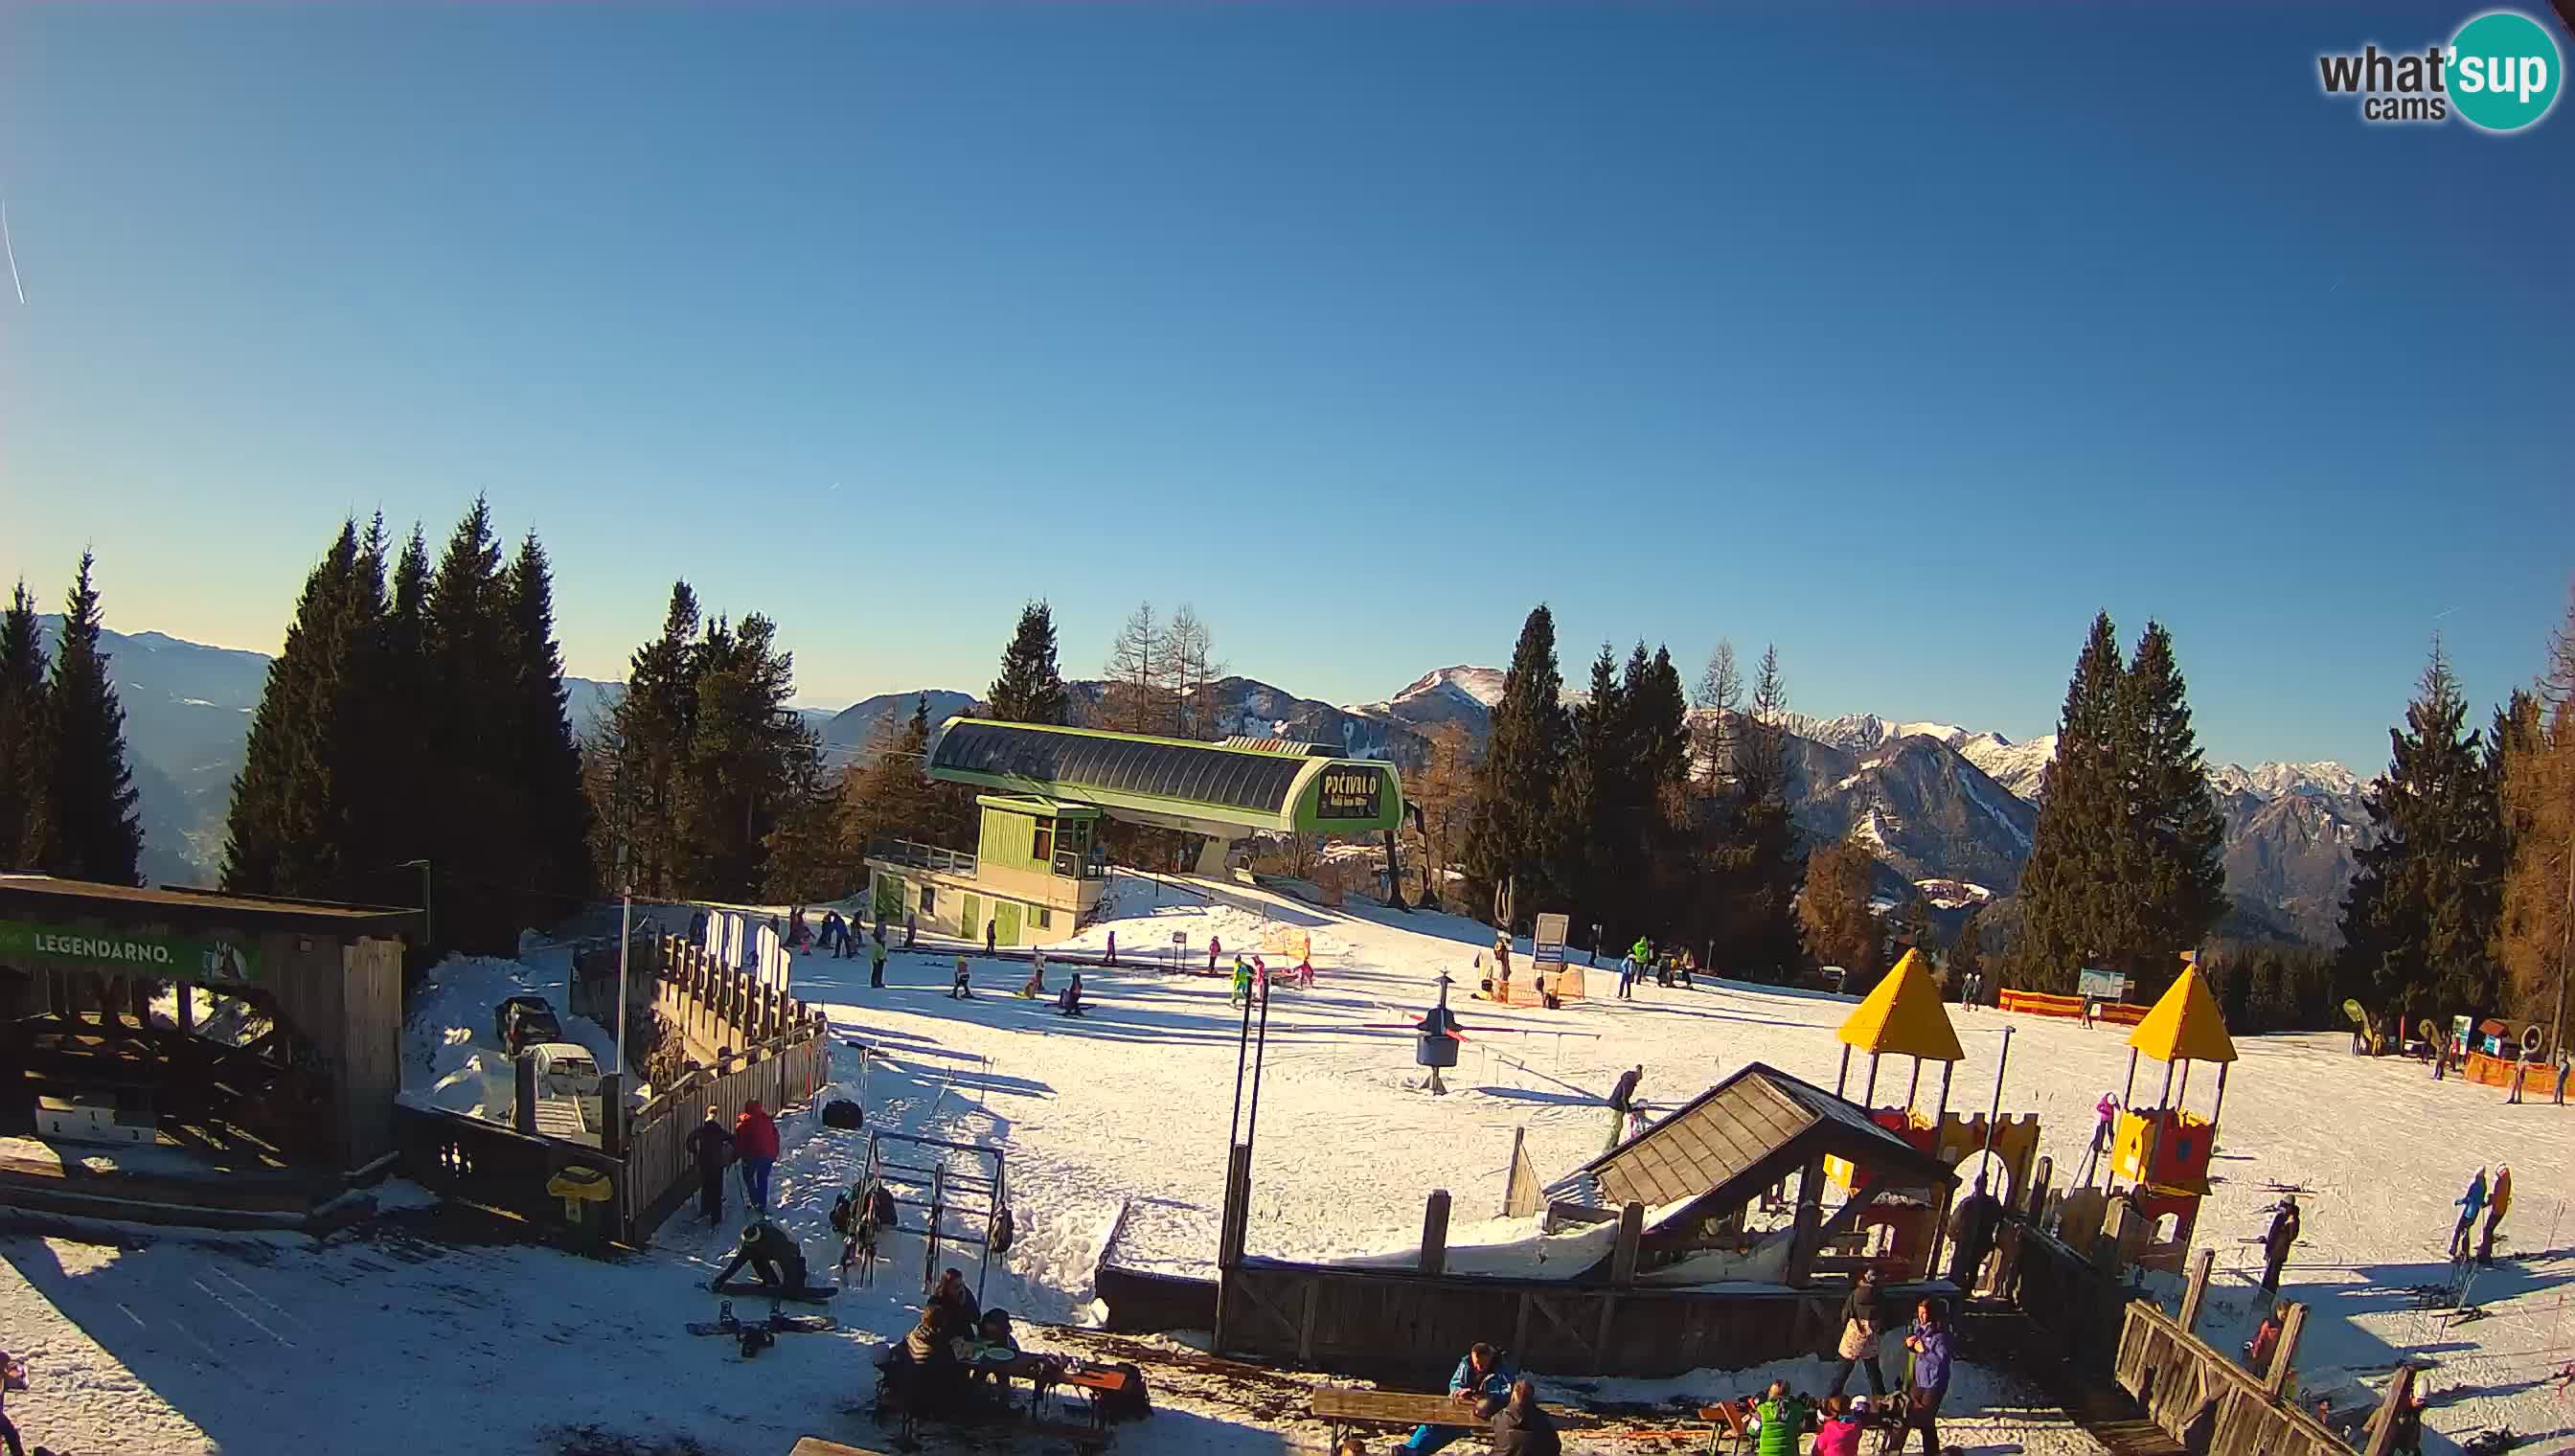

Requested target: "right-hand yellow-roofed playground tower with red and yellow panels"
[{"left": 2108, "top": 953, "right": 2235, "bottom": 1273}]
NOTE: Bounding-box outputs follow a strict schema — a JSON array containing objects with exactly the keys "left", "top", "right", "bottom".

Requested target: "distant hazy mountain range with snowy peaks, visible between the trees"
[{"left": 44, "top": 616, "right": 2369, "bottom": 941}]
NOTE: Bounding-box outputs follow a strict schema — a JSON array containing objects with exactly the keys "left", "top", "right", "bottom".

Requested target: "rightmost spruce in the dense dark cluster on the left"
[{"left": 502, "top": 531, "right": 592, "bottom": 897}]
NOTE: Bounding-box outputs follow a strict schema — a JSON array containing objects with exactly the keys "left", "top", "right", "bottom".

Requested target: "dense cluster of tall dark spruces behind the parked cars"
[{"left": 221, "top": 497, "right": 595, "bottom": 953}]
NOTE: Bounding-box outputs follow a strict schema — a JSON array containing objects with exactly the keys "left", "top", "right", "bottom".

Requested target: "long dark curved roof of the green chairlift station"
[{"left": 929, "top": 719, "right": 1313, "bottom": 814}]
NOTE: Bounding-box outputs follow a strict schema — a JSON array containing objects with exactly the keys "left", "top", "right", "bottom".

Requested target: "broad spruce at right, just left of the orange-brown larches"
[{"left": 2336, "top": 645, "right": 2503, "bottom": 1023}]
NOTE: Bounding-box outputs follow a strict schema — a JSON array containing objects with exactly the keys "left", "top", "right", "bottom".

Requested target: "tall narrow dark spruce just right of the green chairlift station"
[{"left": 1465, "top": 603, "right": 1568, "bottom": 920}]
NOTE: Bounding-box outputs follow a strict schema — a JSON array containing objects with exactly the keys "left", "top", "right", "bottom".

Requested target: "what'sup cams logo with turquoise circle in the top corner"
[{"left": 2315, "top": 11, "right": 2564, "bottom": 131}]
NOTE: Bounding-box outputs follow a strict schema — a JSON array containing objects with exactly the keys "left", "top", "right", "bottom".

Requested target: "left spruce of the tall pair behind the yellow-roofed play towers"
[{"left": 2003, "top": 613, "right": 2137, "bottom": 992}]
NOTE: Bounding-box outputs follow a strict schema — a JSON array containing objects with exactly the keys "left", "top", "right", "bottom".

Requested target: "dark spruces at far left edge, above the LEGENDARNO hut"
[{"left": 0, "top": 552, "right": 145, "bottom": 884}]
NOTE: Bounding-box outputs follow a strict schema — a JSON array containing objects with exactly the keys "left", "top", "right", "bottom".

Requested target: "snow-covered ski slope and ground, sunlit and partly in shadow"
[{"left": 0, "top": 881, "right": 2575, "bottom": 1456}]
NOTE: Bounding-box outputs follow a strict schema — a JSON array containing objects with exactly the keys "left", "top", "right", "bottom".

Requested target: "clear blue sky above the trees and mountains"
[{"left": 0, "top": 5, "right": 2575, "bottom": 770}]
